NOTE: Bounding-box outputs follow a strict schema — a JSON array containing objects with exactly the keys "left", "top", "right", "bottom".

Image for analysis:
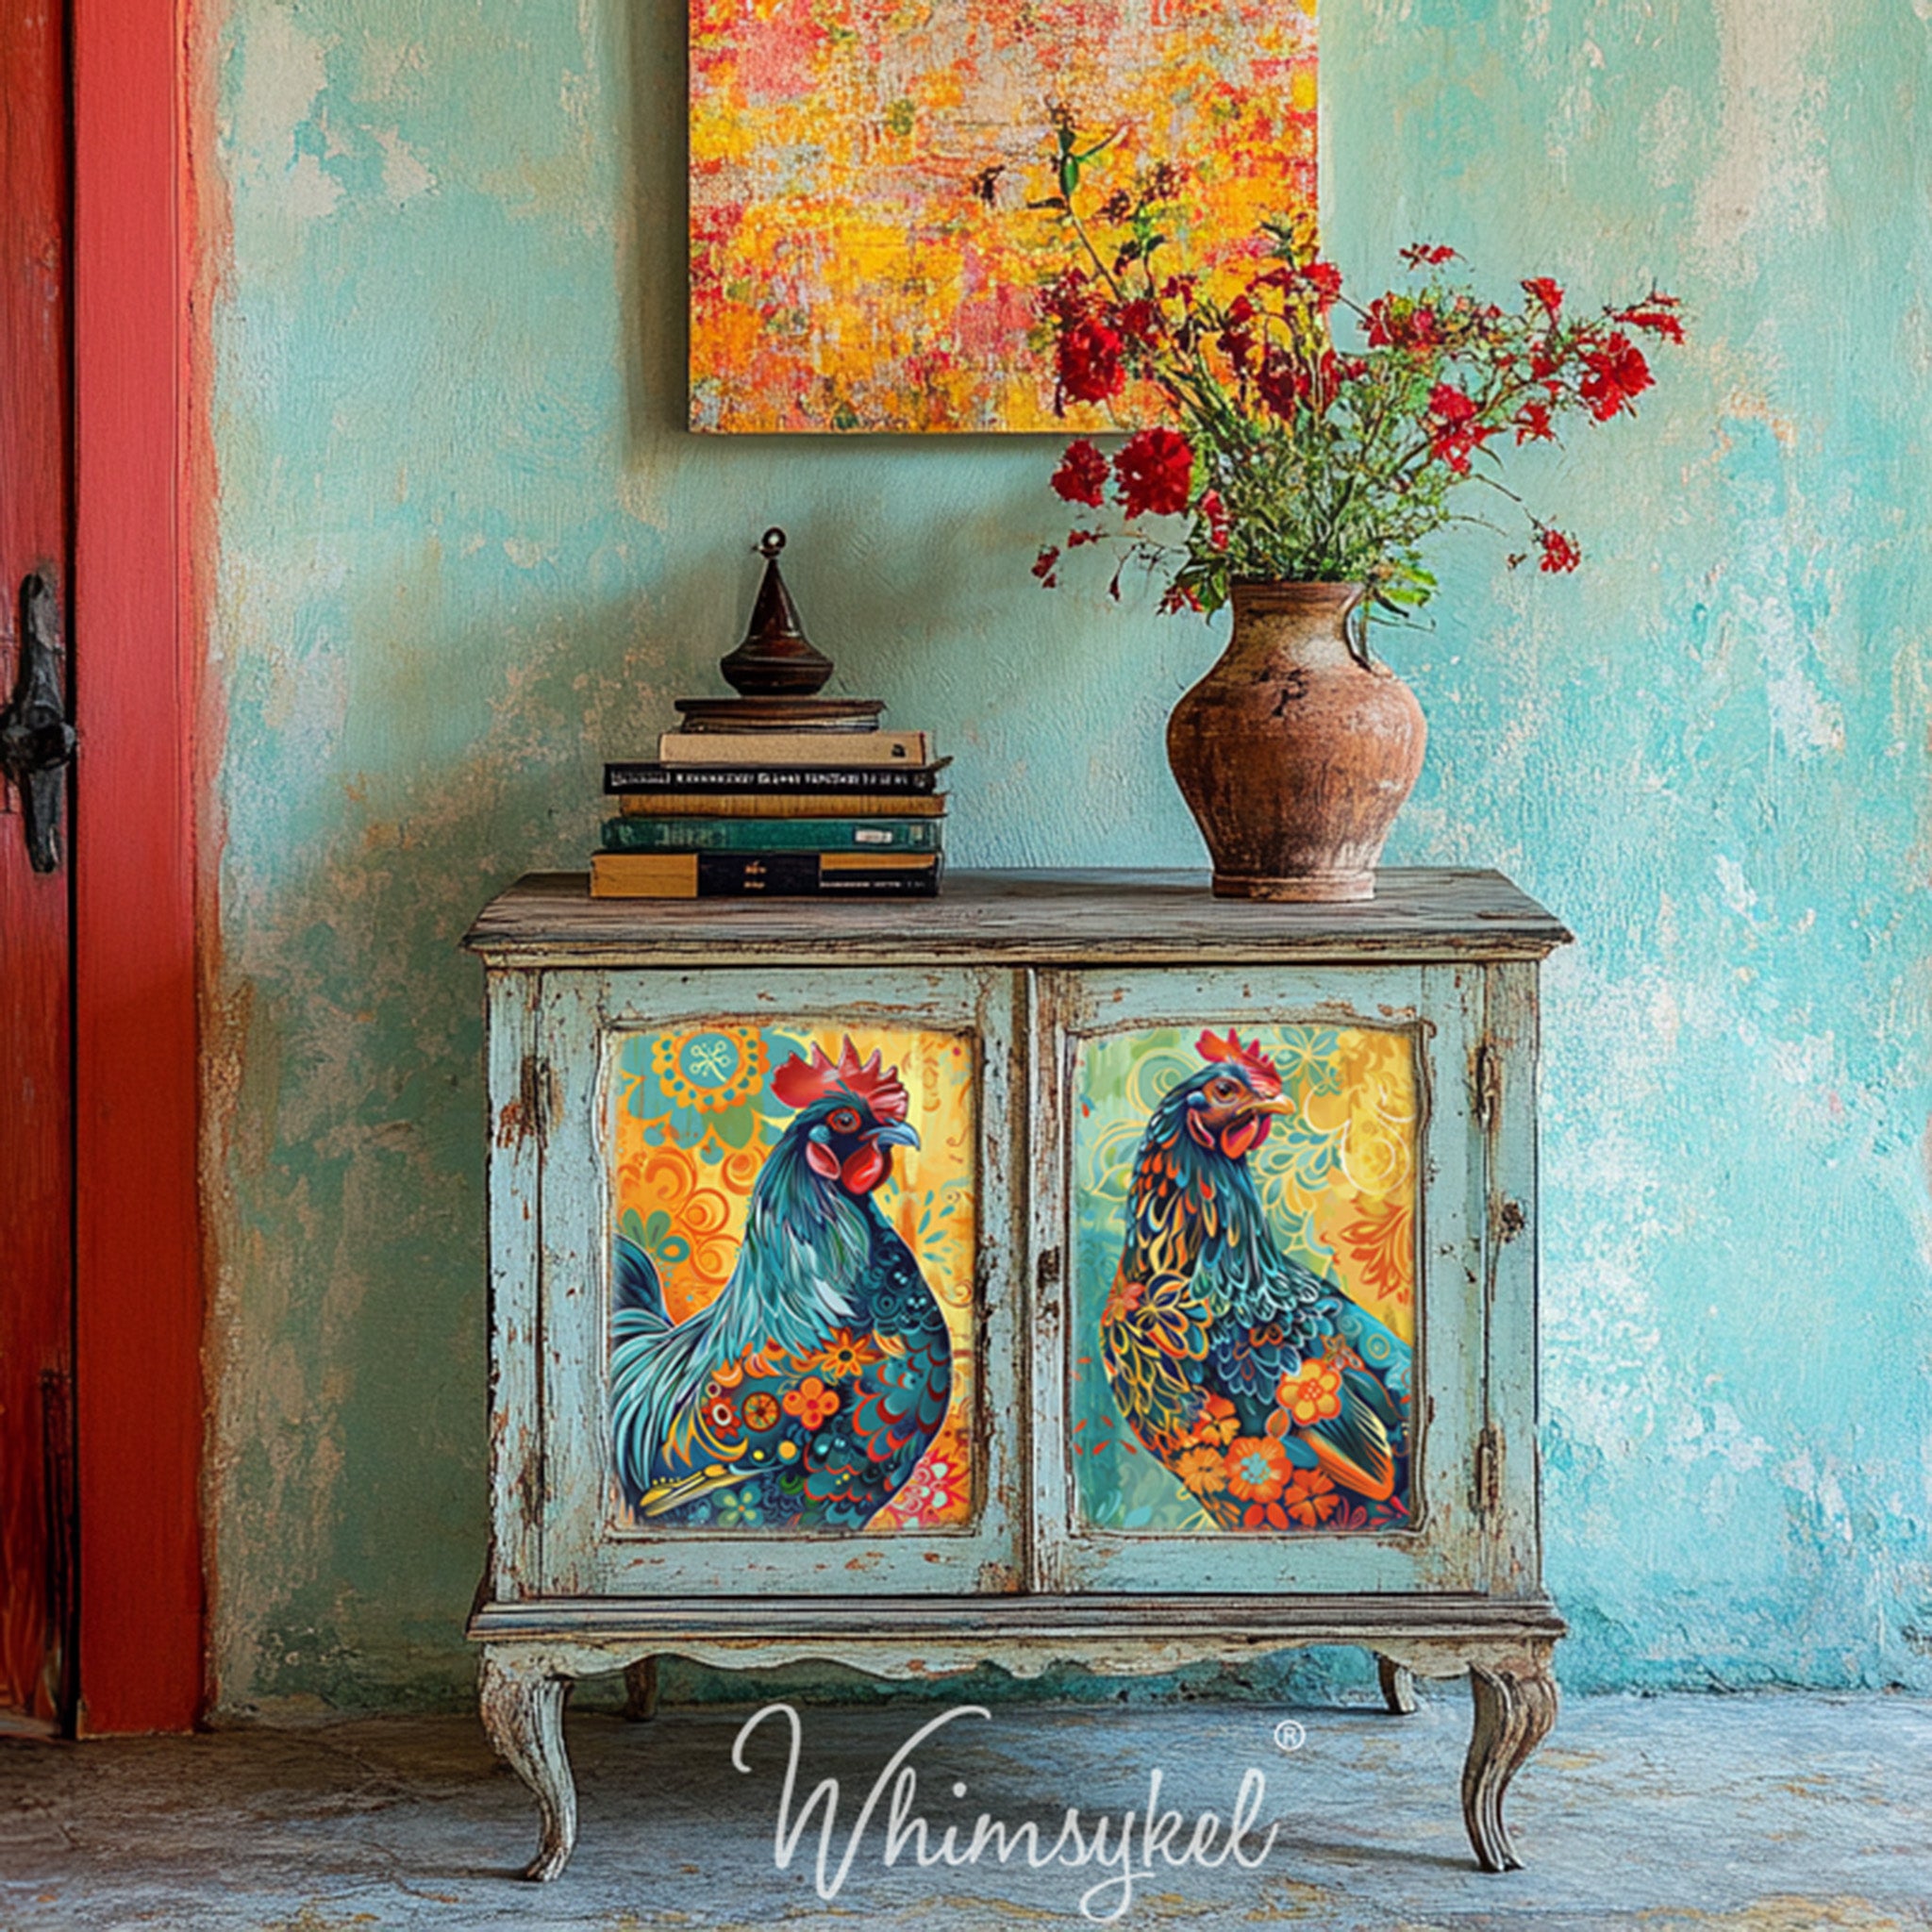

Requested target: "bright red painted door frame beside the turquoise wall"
[{"left": 70, "top": 0, "right": 207, "bottom": 1735}]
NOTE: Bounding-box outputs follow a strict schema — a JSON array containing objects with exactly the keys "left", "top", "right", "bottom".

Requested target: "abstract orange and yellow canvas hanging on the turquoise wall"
[{"left": 690, "top": 0, "right": 1316, "bottom": 433}]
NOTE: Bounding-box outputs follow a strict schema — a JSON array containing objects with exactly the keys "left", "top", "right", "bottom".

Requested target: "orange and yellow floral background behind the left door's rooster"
[{"left": 607, "top": 1020, "right": 977, "bottom": 1530}]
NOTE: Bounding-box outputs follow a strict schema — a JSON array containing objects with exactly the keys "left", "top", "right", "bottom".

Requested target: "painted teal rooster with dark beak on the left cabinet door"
[{"left": 610, "top": 1040, "right": 953, "bottom": 1530}]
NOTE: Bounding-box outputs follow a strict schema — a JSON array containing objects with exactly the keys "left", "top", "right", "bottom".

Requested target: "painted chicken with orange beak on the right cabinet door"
[{"left": 1099, "top": 1030, "right": 1410, "bottom": 1530}]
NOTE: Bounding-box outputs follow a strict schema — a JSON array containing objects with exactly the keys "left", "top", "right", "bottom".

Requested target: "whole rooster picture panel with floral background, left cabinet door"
[{"left": 608, "top": 1024, "right": 974, "bottom": 1532}]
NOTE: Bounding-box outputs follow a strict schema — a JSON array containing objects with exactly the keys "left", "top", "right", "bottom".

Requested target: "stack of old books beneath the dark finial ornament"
[{"left": 591, "top": 724, "right": 951, "bottom": 898}]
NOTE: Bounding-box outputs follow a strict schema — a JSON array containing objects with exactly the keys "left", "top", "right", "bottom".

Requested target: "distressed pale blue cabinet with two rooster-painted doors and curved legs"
[{"left": 466, "top": 872, "right": 1569, "bottom": 1878}]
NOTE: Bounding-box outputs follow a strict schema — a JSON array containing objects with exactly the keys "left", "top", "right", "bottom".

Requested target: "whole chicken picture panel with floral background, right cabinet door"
[{"left": 1074, "top": 1025, "right": 1416, "bottom": 1532}]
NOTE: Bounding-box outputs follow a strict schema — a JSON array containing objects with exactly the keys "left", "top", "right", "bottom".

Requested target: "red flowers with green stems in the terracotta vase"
[{"left": 1032, "top": 110, "right": 1683, "bottom": 612}]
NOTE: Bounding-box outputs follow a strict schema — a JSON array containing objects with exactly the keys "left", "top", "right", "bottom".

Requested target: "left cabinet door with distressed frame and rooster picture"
[{"left": 537, "top": 970, "right": 1020, "bottom": 1596}]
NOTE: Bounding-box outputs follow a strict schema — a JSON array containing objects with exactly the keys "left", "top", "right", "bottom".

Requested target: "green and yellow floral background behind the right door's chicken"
[{"left": 1071, "top": 1025, "right": 1418, "bottom": 1532}]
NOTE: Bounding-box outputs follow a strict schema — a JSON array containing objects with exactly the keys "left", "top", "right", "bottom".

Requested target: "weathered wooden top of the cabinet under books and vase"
[{"left": 464, "top": 868, "right": 1571, "bottom": 966}]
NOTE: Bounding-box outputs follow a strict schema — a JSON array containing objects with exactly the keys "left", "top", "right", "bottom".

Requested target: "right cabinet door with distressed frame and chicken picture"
[{"left": 1034, "top": 966, "right": 1484, "bottom": 1592}]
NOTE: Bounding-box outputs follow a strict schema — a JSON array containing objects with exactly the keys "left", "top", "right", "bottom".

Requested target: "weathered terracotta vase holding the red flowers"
[{"left": 1167, "top": 583, "right": 1427, "bottom": 900}]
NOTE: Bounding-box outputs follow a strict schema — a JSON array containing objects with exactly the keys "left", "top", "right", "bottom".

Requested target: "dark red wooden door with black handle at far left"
[{"left": 0, "top": 0, "right": 75, "bottom": 1731}]
